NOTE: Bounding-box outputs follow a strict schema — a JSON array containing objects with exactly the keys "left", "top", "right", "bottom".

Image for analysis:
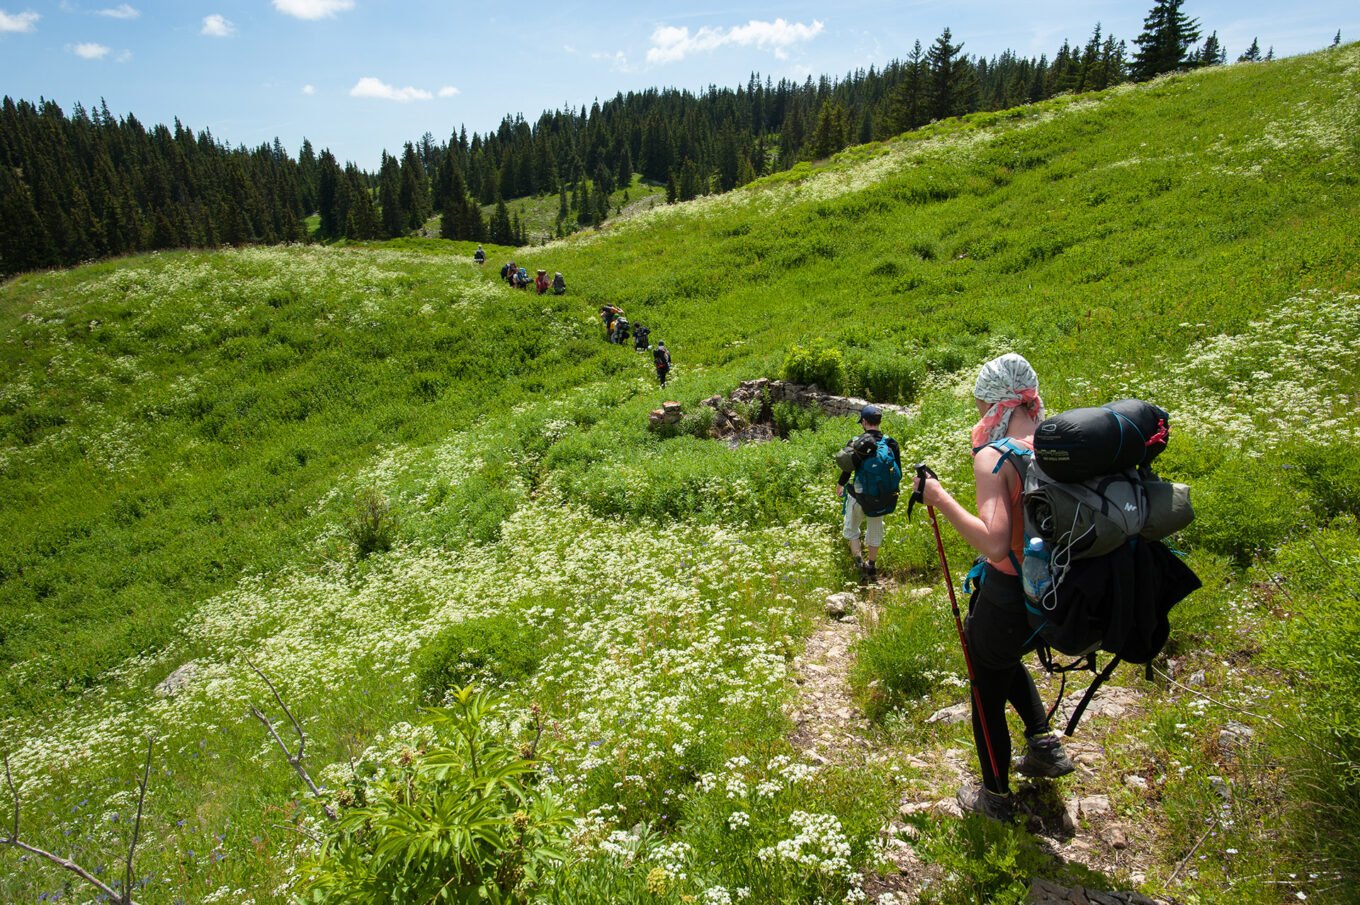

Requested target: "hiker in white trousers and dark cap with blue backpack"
[{"left": 836, "top": 406, "right": 902, "bottom": 581}]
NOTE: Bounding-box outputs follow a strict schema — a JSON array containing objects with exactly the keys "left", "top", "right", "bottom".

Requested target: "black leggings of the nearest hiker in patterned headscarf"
[{"left": 964, "top": 565, "right": 1049, "bottom": 795}]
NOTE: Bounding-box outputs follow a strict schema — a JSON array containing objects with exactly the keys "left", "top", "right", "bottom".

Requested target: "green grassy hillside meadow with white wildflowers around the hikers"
[{"left": 0, "top": 45, "right": 1360, "bottom": 905}]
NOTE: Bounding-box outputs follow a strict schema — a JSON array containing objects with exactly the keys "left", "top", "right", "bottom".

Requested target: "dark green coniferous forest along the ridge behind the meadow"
[{"left": 0, "top": 0, "right": 1272, "bottom": 274}]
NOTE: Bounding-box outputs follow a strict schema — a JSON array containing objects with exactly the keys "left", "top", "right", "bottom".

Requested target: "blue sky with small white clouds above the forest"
[{"left": 0, "top": 0, "right": 1360, "bottom": 170}]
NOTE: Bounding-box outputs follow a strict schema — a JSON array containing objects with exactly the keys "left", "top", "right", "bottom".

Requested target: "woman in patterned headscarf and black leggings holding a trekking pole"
[{"left": 915, "top": 352, "right": 1073, "bottom": 821}]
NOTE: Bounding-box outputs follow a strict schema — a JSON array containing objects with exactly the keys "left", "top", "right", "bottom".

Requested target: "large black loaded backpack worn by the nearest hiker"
[{"left": 987, "top": 399, "right": 1200, "bottom": 735}]
